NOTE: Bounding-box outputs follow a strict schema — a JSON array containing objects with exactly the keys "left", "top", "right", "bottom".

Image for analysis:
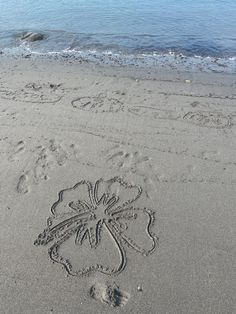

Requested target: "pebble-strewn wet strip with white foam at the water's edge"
[{"left": 0, "top": 46, "right": 236, "bottom": 74}]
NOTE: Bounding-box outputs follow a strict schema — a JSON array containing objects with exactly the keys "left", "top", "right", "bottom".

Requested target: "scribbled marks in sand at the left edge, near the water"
[{"left": 0, "top": 83, "right": 63, "bottom": 103}]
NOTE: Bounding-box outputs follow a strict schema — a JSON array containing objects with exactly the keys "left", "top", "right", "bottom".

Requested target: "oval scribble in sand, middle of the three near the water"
[{"left": 71, "top": 94, "right": 124, "bottom": 113}]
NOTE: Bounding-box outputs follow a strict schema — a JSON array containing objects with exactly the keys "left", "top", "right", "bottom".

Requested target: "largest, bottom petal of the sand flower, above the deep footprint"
[{"left": 49, "top": 223, "right": 126, "bottom": 276}]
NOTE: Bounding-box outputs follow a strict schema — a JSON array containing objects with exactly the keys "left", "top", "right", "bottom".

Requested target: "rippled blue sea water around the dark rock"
[{"left": 0, "top": 0, "right": 236, "bottom": 70}]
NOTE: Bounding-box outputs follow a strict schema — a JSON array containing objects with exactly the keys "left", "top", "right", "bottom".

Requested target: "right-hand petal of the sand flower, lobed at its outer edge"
[{"left": 109, "top": 208, "right": 157, "bottom": 256}]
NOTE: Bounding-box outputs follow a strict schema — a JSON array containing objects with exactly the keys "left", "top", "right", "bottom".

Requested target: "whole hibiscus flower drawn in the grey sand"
[{"left": 34, "top": 177, "right": 157, "bottom": 276}]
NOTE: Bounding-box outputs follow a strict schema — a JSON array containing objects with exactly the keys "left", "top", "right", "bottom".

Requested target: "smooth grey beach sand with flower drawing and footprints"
[{"left": 0, "top": 57, "right": 236, "bottom": 314}]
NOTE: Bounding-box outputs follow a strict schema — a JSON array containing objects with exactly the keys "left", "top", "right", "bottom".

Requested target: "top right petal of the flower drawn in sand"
[{"left": 94, "top": 177, "right": 142, "bottom": 211}]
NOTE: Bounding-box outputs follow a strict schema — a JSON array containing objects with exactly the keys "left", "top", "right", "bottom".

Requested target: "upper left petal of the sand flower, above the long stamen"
[{"left": 51, "top": 181, "right": 93, "bottom": 215}]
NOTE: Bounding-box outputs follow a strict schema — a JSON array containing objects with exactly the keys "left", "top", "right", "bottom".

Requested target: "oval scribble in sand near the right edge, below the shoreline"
[{"left": 183, "top": 111, "right": 231, "bottom": 129}]
